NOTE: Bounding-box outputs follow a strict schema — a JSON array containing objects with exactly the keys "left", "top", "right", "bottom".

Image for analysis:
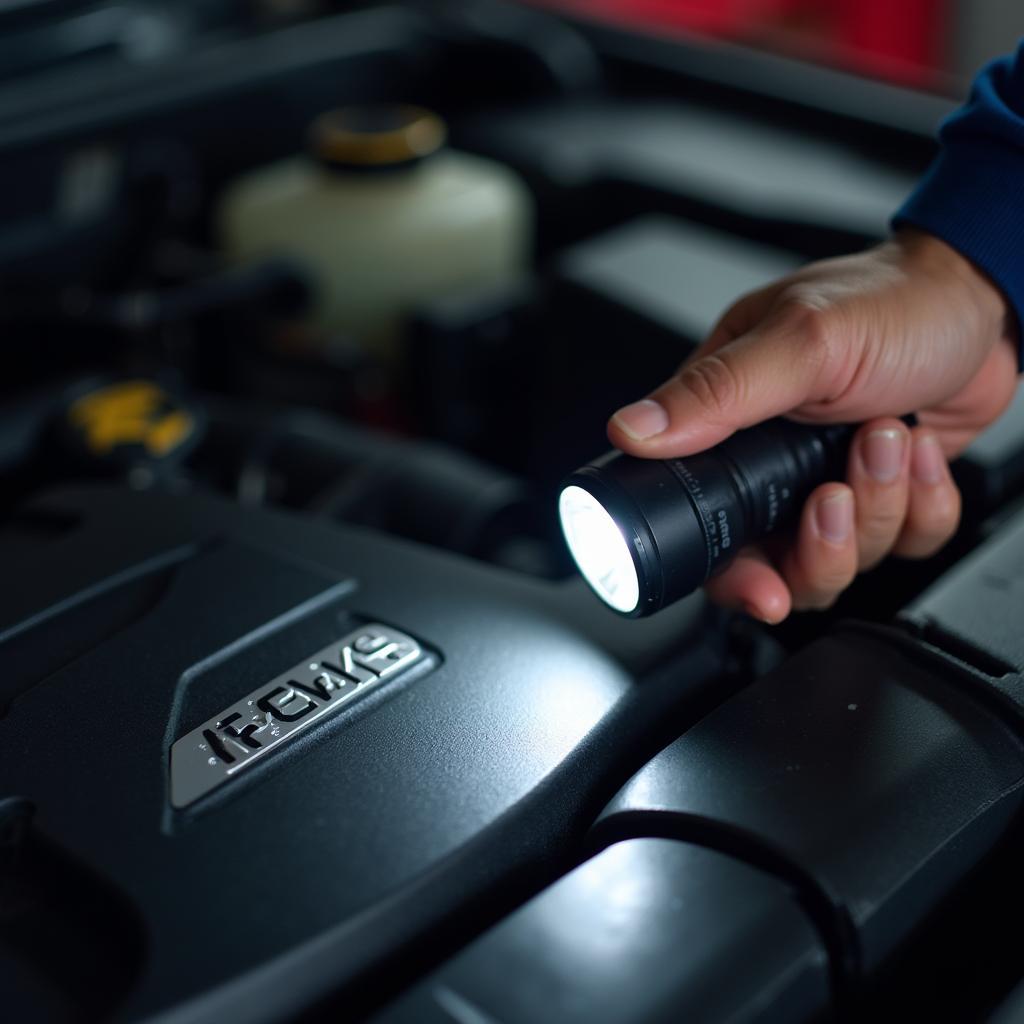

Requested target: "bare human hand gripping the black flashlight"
[{"left": 608, "top": 230, "right": 1017, "bottom": 623}]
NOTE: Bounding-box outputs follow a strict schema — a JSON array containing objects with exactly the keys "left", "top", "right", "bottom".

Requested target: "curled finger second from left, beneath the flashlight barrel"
[{"left": 781, "top": 483, "right": 857, "bottom": 609}]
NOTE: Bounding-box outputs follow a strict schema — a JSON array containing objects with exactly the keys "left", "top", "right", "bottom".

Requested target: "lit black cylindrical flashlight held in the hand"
[{"left": 558, "top": 419, "right": 855, "bottom": 618}]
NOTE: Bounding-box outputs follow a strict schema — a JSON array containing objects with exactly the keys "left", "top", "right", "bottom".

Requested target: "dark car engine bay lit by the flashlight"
[{"left": 6, "top": 0, "right": 1024, "bottom": 1024}]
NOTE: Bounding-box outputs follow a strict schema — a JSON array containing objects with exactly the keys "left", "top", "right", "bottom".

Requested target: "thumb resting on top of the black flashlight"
[{"left": 608, "top": 317, "right": 838, "bottom": 459}]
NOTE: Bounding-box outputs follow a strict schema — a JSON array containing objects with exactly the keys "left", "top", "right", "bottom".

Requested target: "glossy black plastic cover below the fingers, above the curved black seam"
[{"left": 597, "top": 631, "right": 1024, "bottom": 975}]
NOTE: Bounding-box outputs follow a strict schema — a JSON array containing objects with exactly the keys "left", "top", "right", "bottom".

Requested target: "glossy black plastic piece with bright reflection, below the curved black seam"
[{"left": 374, "top": 839, "right": 828, "bottom": 1024}]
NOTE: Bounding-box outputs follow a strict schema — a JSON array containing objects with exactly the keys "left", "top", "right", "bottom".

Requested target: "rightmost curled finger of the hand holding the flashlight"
[{"left": 893, "top": 428, "right": 961, "bottom": 558}]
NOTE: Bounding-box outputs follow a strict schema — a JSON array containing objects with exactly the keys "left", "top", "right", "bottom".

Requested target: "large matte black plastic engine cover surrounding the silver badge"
[{"left": 0, "top": 488, "right": 720, "bottom": 1021}]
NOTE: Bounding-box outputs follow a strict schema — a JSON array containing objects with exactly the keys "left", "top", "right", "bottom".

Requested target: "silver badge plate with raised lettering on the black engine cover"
[{"left": 171, "top": 623, "right": 426, "bottom": 808}]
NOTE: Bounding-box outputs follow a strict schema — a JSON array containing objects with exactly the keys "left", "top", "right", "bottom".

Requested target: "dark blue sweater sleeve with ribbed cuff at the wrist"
[{"left": 893, "top": 42, "right": 1024, "bottom": 354}]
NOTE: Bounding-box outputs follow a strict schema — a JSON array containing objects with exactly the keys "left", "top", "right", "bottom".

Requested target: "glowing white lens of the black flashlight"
[{"left": 558, "top": 484, "right": 640, "bottom": 612}]
